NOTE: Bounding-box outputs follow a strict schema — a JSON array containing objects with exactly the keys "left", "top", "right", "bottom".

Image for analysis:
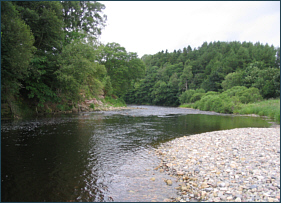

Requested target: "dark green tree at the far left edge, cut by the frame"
[{"left": 1, "top": 1, "right": 35, "bottom": 100}]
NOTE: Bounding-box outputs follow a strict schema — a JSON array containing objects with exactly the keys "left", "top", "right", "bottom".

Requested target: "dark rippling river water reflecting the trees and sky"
[{"left": 1, "top": 106, "right": 270, "bottom": 202}]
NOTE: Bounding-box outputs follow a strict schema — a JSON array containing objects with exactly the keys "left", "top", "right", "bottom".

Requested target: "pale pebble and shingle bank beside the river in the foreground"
[{"left": 156, "top": 126, "right": 280, "bottom": 202}]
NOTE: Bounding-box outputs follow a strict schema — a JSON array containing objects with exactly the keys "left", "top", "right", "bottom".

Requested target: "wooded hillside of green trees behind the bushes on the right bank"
[{"left": 124, "top": 41, "right": 280, "bottom": 106}]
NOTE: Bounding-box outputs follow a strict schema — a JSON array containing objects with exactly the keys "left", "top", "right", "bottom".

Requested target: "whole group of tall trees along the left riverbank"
[{"left": 1, "top": 1, "right": 145, "bottom": 114}]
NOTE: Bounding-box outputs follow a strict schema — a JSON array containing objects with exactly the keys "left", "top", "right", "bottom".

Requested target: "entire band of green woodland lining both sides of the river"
[{"left": 1, "top": 1, "right": 280, "bottom": 116}]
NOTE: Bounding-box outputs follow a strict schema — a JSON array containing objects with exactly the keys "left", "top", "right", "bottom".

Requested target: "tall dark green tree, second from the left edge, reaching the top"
[{"left": 15, "top": 1, "right": 63, "bottom": 106}]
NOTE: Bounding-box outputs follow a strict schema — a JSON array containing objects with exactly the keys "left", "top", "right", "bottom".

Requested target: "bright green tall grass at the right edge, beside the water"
[{"left": 234, "top": 99, "right": 280, "bottom": 123}]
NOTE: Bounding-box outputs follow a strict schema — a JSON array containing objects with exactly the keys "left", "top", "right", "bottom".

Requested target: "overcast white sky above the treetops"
[{"left": 100, "top": 1, "right": 280, "bottom": 57}]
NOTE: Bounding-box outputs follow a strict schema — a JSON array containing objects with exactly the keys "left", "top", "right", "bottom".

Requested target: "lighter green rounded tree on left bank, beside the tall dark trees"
[{"left": 55, "top": 41, "right": 106, "bottom": 102}]
